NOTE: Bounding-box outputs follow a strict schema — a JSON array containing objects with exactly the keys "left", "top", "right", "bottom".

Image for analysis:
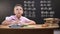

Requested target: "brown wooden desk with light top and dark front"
[{"left": 0, "top": 25, "right": 58, "bottom": 34}]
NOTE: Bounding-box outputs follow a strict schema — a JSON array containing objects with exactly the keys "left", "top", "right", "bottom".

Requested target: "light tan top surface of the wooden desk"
[{"left": 0, "top": 24, "right": 59, "bottom": 29}]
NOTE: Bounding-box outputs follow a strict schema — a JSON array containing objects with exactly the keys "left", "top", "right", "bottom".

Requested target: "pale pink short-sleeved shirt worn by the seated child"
[{"left": 5, "top": 15, "right": 31, "bottom": 24}]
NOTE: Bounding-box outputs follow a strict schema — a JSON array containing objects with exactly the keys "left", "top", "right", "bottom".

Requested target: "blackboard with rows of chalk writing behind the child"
[{"left": 0, "top": 0, "right": 60, "bottom": 24}]
